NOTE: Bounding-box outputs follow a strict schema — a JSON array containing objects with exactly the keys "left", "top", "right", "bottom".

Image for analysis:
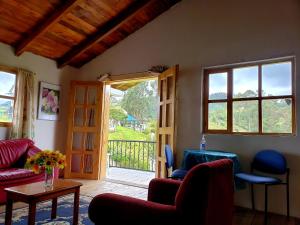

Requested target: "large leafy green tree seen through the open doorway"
[{"left": 121, "top": 80, "right": 158, "bottom": 121}]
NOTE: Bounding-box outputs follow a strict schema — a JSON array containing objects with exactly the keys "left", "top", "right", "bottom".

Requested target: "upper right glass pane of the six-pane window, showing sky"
[{"left": 262, "top": 62, "right": 292, "bottom": 96}]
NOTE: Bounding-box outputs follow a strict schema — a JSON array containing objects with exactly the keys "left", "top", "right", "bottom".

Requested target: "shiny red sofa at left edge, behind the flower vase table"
[{"left": 0, "top": 139, "right": 44, "bottom": 204}]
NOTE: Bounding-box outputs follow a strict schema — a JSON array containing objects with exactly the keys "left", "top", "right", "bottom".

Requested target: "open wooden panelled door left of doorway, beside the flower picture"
[{"left": 65, "top": 81, "right": 107, "bottom": 179}]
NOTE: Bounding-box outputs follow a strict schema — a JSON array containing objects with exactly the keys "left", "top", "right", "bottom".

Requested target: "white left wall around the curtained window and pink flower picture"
[{"left": 0, "top": 44, "right": 79, "bottom": 152}]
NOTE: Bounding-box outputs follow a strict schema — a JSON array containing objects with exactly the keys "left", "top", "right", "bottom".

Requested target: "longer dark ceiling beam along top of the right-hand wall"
[{"left": 57, "top": 0, "right": 155, "bottom": 68}]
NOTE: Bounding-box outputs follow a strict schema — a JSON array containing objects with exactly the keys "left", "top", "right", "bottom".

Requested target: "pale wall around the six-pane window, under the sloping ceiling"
[{"left": 81, "top": 0, "right": 300, "bottom": 217}]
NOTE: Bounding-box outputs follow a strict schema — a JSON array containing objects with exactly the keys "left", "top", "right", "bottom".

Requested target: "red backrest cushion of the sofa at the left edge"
[{"left": 0, "top": 139, "right": 33, "bottom": 169}]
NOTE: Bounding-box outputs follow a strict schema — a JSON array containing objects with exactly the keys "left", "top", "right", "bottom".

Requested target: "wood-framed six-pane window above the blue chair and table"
[{"left": 203, "top": 58, "right": 296, "bottom": 134}]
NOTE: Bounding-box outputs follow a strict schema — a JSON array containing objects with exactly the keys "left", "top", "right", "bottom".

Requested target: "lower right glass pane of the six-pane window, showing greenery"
[{"left": 262, "top": 98, "right": 292, "bottom": 133}]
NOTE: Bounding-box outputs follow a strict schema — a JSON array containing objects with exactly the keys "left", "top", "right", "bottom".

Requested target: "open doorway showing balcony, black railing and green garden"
[{"left": 106, "top": 78, "right": 159, "bottom": 186}]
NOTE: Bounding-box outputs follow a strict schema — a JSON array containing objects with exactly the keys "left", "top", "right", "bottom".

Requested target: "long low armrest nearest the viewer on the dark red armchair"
[{"left": 88, "top": 194, "right": 176, "bottom": 225}]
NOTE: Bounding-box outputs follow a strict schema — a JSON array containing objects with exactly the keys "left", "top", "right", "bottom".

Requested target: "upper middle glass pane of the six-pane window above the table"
[{"left": 233, "top": 66, "right": 258, "bottom": 98}]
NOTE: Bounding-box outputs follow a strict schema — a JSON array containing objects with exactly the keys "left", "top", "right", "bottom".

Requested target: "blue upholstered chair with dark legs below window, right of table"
[{"left": 235, "top": 150, "right": 290, "bottom": 225}]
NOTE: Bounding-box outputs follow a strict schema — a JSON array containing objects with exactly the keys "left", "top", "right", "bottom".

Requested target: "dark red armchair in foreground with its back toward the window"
[{"left": 89, "top": 159, "right": 233, "bottom": 225}]
